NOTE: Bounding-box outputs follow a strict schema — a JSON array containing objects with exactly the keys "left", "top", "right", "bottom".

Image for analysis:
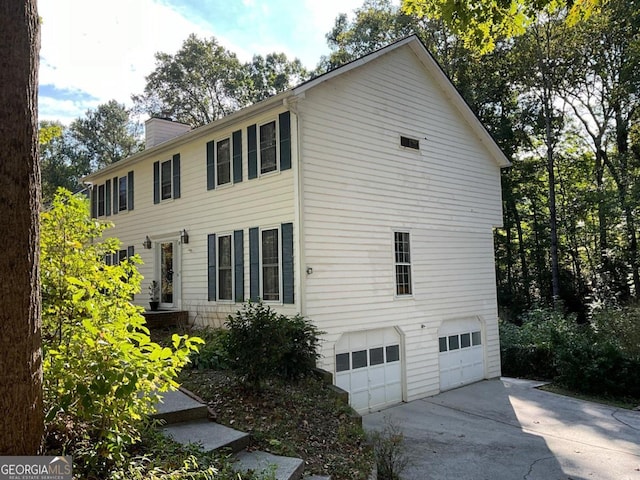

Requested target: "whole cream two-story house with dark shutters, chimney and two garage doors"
[{"left": 86, "top": 36, "right": 509, "bottom": 412}]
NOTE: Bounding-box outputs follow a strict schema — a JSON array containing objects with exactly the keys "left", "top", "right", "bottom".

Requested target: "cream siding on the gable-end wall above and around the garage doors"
[{"left": 298, "top": 47, "right": 502, "bottom": 400}]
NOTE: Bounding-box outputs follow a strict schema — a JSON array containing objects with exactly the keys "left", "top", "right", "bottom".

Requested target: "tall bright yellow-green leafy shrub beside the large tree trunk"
[{"left": 41, "top": 190, "right": 201, "bottom": 470}]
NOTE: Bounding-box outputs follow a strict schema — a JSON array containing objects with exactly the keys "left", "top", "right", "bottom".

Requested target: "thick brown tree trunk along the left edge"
[{"left": 0, "top": 0, "right": 44, "bottom": 455}]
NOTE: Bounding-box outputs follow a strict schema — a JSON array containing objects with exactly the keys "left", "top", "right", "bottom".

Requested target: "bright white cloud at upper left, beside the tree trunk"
[{"left": 39, "top": 0, "right": 211, "bottom": 119}]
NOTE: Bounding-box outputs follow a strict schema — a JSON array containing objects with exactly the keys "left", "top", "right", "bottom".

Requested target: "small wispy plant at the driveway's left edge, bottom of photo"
[{"left": 368, "top": 417, "right": 409, "bottom": 480}]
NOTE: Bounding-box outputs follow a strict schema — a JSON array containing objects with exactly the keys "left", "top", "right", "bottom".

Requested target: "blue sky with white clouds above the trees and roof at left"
[{"left": 38, "top": 0, "right": 380, "bottom": 124}]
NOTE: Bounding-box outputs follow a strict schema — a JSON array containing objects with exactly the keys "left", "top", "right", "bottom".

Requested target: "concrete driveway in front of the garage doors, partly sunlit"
[{"left": 363, "top": 378, "right": 640, "bottom": 480}]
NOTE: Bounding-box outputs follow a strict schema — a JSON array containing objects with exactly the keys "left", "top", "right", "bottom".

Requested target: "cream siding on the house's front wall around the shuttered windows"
[{"left": 89, "top": 109, "right": 300, "bottom": 325}]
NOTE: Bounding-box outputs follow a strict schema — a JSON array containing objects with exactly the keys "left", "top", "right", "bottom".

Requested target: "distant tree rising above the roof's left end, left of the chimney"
[{"left": 68, "top": 100, "right": 142, "bottom": 173}]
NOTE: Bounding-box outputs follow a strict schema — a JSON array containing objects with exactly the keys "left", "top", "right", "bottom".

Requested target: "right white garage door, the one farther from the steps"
[{"left": 438, "top": 319, "right": 484, "bottom": 391}]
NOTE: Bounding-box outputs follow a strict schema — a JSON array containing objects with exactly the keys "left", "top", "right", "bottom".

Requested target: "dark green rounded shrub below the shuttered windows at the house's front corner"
[{"left": 226, "top": 302, "right": 321, "bottom": 387}]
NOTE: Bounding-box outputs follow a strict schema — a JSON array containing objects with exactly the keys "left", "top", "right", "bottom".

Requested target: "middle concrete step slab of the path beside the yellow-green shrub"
[{"left": 162, "top": 418, "right": 251, "bottom": 453}]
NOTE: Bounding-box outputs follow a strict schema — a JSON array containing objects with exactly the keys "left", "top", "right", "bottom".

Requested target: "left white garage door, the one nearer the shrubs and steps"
[{"left": 335, "top": 328, "right": 402, "bottom": 413}]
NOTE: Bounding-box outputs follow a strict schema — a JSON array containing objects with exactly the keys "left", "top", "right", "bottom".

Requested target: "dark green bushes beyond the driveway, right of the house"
[{"left": 500, "top": 308, "right": 640, "bottom": 398}]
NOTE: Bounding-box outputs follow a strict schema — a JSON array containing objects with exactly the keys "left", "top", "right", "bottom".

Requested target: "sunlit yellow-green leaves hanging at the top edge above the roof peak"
[{"left": 402, "top": 0, "right": 603, "bottom": 53}]
